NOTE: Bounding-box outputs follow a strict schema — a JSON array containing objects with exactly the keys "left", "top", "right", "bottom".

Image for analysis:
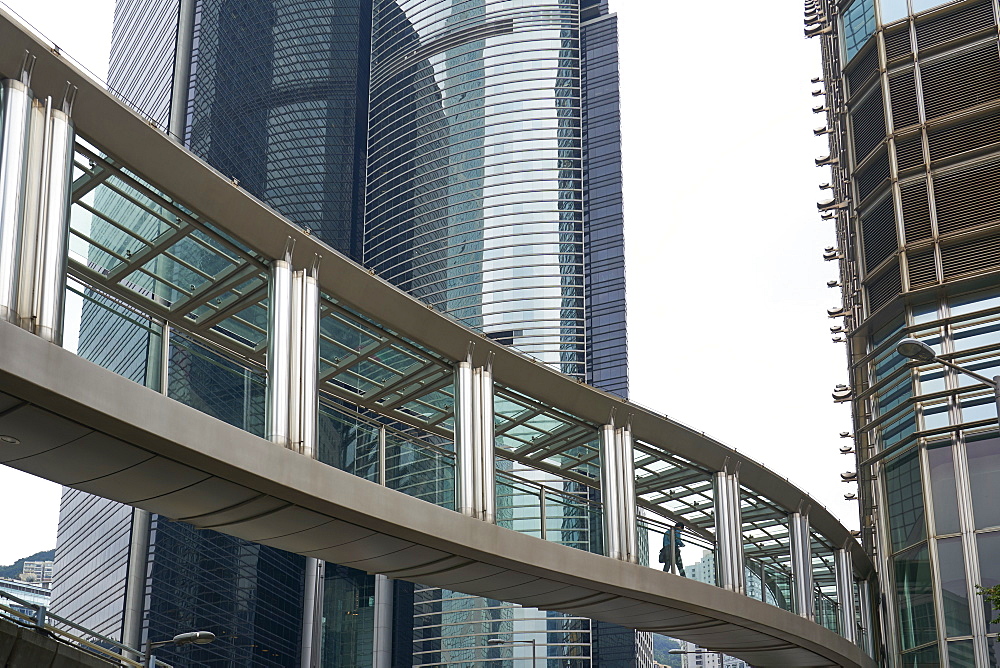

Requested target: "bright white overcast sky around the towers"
[{"left": 0, "top": 0, "right": 858, "bottom": 564}]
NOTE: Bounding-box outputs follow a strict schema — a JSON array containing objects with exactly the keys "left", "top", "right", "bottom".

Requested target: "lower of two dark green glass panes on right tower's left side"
[{"left": 893, "top": 545, "right": 937, "bottom": 648}]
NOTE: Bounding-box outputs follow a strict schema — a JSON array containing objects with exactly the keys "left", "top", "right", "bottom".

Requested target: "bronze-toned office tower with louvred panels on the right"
[{"left": 806, "top": 0, "right": 1000, "bottom": 668}]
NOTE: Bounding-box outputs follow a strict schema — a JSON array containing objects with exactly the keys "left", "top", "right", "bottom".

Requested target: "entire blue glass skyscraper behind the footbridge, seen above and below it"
[{"left": 56, "top": 0, "right": 632, "bottom": 666}]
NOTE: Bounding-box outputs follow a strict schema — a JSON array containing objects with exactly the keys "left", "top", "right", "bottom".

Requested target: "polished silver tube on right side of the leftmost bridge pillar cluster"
[{"left": 35, "top": 103, "right": 73, "bottom": 345}]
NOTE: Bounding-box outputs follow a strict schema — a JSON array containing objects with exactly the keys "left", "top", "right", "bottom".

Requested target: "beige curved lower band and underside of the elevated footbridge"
[{"left": 0, "top": 322, "right": 874, "bottom": 666}]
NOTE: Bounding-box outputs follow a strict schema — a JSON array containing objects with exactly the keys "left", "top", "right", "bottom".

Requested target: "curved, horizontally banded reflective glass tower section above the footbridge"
[{"left": 364, "top": 0, "right": 586, "bottom": 377}]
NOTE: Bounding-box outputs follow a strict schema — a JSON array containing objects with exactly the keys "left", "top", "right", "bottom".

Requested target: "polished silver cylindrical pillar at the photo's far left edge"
[{"left": 0, "top": 79, "right": 32, "bottom": 322}]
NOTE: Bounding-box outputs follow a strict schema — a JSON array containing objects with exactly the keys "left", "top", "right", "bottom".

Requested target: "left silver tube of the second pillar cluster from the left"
[{"left": 266, "top": 259, "right": 292, "bottom": 446}]
